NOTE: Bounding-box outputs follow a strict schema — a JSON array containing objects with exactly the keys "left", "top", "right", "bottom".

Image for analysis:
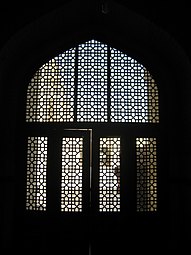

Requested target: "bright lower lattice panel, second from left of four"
[{"left": 61, "top": 137, "right": 83, "bottom": 212}]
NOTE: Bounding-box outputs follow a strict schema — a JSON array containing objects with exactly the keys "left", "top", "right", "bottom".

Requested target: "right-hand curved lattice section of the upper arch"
[{"left": 111, "top": 48, "right": 159, "bottom": 123}]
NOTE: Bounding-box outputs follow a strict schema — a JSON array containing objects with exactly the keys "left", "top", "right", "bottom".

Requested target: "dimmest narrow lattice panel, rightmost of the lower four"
[{"left": 136, "top": 138, "right": 157, "bottom": 212}]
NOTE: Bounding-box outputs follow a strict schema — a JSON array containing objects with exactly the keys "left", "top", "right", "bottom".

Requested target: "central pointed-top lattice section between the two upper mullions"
[{"left": 77, "top": 40, "right": 108, "bottom": 122}]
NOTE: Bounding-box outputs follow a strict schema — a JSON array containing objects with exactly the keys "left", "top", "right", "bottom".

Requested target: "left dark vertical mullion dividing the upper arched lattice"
[{"left": 74, "top": 46, "right": 79, "bottom": 122}]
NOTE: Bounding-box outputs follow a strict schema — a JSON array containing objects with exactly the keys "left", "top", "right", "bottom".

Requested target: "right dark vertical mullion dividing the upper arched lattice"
[{"left": 107, "top": 46, "right": 111, "bottom": 122}]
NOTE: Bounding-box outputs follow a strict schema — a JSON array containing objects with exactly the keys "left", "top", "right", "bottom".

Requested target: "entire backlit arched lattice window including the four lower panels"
[{"left": 26, "top": 40, "right": 159, "bottom": 212}]
